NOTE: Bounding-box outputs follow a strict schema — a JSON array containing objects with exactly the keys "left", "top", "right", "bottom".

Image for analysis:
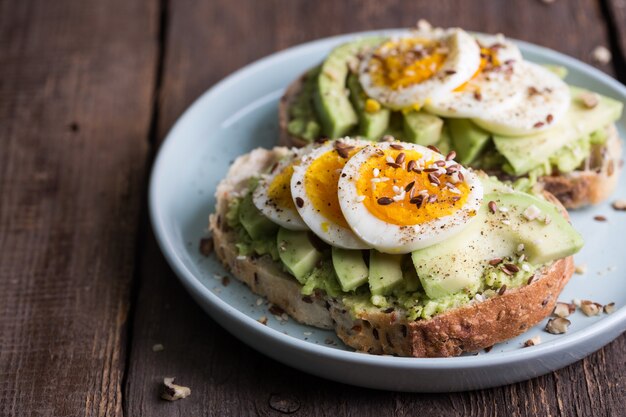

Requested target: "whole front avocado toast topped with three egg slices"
[{"left": 210, "top": 138, "right": 583, "bottom": 357}]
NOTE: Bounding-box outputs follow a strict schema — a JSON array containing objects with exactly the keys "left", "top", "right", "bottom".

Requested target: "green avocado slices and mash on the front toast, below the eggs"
[{"left": 226, "top": 175, "right": 583, "bottom": 320}]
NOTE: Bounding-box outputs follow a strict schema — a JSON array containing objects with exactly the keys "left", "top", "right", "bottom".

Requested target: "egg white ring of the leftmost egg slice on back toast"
[{"left": 359, "top": 28, "right": 480, "bottom": 110}]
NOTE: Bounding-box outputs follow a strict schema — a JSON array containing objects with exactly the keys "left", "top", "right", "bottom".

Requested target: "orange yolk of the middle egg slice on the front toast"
[{"left": 304, "top": 148, "right": 361, "bottom": 229}]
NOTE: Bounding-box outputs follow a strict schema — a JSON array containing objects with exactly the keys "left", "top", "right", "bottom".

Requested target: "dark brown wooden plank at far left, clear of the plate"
[{"left": 0, "top": 0, "right": 157, "bottom": 416}]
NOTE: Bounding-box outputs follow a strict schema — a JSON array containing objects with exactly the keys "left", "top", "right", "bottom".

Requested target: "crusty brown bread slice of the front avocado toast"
[{"left": 209, "top": 148, "right": 574, "bottom": 357}]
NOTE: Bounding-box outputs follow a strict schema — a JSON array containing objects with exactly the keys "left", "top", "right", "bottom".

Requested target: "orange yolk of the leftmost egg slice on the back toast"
[{"left": 369, "top": 38, "right": 447, "bottom": 90}]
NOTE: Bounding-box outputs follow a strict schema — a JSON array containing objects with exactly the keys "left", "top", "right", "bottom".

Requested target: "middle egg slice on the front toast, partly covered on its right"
[{"left": 291, "top": 138, "right": 370, "bottom": 249}]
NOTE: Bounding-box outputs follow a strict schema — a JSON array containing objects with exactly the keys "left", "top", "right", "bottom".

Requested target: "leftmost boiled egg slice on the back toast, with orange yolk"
[{"left": 359, "top": 29, "right": 480, "bottom": 110}]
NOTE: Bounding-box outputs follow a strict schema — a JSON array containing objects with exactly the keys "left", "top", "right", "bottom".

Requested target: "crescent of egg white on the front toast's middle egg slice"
[{"left": 291, "top": 138, "right": 370, "bottom": 249}]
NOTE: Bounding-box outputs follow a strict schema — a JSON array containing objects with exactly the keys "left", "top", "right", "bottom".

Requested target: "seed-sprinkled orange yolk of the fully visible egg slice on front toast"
[{"left": 357, "top": 149, "right": 469, "bottom": 226}]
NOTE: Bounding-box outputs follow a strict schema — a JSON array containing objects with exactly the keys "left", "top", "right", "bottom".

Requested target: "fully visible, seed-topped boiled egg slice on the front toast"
[{"left": 338, "top": 142, "right": 483, "bottom": 253}]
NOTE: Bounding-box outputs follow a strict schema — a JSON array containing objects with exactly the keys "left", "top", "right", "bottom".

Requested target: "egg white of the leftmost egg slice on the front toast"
[{"left": 252, "top": 151, "right": 309, "bottom": 230}]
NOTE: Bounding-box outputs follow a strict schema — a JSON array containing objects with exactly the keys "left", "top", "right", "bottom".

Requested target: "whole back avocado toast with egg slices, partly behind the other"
[{"left": 279, "top": 24, "right": 623, "bottom": 208}]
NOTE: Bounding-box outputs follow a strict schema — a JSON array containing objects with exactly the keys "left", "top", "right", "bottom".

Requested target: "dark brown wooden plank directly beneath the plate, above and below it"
[{"left": 126, "top": 0, "right": 626, "bottom": 417}]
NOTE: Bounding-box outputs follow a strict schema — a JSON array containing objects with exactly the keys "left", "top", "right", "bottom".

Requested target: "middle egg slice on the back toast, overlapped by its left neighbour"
[{"left": 425, "top": 35, "right": 525, "bottom": 118}]
